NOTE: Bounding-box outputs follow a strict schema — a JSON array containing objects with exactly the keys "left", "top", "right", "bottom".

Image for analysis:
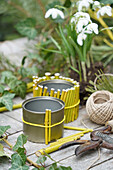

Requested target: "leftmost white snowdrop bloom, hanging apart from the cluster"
[{"left": 45, "top": 8, "right": 64, "bottom": 19}]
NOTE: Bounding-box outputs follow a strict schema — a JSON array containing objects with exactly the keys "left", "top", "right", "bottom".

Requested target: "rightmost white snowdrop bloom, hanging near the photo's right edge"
[{"left": 97, "top": 6, "right": 112, "bottom": 18}]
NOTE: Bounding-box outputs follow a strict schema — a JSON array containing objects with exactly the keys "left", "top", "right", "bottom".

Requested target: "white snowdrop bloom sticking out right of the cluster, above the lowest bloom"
[{"left": 84, "top": 23, "right": 98, "bottom": 34}]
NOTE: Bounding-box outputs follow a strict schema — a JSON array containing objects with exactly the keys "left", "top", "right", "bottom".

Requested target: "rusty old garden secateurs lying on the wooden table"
[{"left": 59, "top": 125, "right": 113, "bottom": 156}]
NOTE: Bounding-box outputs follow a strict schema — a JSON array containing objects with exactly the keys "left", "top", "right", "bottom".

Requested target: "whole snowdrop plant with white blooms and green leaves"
[{"left": 39, "top": 0, "right": 112, "bottom": 82}]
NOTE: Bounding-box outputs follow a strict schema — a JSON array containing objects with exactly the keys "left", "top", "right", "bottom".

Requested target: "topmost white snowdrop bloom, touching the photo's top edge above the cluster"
[{"left": 77, "top": 0, "right": 93, "bottom": 11}]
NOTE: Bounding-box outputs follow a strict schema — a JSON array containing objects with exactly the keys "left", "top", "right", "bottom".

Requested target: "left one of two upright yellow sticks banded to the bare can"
[{"left": 45, "top": 109, "right": 49, "bottom": 145}]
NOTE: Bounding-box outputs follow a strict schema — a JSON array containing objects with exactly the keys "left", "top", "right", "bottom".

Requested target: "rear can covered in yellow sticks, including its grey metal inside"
[{"left": 32, "top": 72, "right": 80, "bottom": 123}]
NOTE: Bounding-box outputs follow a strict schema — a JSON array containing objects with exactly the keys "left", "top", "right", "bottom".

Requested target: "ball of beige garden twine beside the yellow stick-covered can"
[{"left": 86, "top": 90, "right": 113, "bottom": 124}]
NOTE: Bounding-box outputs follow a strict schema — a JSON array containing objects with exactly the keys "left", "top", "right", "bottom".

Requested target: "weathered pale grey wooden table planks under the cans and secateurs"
[{"left": 0, "top": 93, "right": 113, "bottom": 170}]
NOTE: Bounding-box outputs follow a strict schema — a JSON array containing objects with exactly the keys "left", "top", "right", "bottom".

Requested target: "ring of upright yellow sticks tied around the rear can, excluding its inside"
[{"left": 33, "top": 72, "right": 80, "bottom": 123}]
